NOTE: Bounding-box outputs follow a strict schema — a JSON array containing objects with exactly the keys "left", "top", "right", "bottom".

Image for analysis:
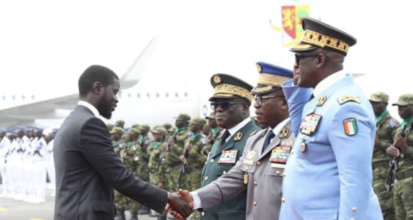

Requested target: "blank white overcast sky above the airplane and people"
[{"left": 0, "top": 0, "right": 413, "bottom": 118}]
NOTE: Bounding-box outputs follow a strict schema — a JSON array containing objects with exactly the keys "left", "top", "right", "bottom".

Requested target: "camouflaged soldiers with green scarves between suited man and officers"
[{"left": 107, "top": 113, "right": 221, "bottom": 220}]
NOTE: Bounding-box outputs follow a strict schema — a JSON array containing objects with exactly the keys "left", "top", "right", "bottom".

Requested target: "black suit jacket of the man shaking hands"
[{"left": 54, "top": 105, "right": 168, "bottom": 220}]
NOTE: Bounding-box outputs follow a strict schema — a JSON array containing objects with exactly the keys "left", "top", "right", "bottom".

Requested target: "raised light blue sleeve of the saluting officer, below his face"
[{"left": 282, "top": 80, "right": 311, "bottom": 136}]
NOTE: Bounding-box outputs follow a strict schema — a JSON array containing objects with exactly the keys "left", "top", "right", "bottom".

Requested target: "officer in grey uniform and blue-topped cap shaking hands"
[{"left": 170, "top": 62, "right": 294, "bottom": 220}]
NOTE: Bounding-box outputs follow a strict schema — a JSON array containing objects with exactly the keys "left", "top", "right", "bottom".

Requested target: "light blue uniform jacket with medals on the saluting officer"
[{"left": 280, "top": 75, "right": 383, "bottom": 220}]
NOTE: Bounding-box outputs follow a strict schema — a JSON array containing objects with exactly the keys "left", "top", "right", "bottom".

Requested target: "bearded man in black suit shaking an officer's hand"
[{"left": 54, "top": 65, "right": 190, "bottom": 220}]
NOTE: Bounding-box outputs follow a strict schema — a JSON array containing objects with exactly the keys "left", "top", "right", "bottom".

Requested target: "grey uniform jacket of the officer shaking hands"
[{"left": 197, "top": 123, "right": 295, "bottom": 220}]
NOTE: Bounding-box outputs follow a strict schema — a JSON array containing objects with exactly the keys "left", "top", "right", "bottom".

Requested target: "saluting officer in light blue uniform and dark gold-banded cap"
[{"left": 280, "top": 17, "right": 383, "bottom": 220}]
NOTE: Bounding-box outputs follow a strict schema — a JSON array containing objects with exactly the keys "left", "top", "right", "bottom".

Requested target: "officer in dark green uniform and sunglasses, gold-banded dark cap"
[{"left": 197, "top": 74, "right": 259, "bottom": 220}]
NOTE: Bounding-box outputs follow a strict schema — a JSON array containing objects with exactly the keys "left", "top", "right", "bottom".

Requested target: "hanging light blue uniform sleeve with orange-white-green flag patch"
[{"left": 328, "top": 102, "right": 375, "bottom": 220}]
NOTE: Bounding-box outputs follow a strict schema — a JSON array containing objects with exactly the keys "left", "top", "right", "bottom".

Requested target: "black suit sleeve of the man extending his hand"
[{"left": 80, "top": 118, "right": 168, "bottom": 211}]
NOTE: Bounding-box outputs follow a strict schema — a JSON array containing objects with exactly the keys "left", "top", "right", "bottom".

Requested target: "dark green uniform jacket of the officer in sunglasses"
[{"left": 200, "top": 121, "right": 259, "bottom": 220}]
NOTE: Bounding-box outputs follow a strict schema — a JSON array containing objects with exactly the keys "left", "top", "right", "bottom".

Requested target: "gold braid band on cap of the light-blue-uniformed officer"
[{"left": 301, "top": 30, "right": 348, "bottom": 53}]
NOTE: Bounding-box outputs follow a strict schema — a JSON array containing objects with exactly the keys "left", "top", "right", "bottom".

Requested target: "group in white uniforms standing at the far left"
[{"left": 0, "top": 127, "right": 57, "bottom": 203}]
